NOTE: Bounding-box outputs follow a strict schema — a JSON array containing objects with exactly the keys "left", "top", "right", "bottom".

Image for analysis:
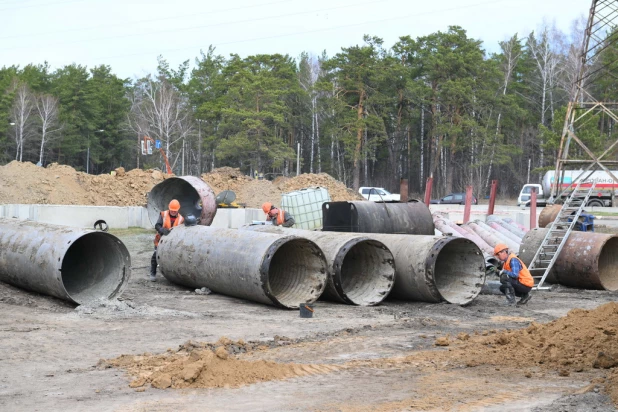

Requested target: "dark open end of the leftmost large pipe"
[{"left": 60, "top": 232, "right": 131, "bottom": 305}]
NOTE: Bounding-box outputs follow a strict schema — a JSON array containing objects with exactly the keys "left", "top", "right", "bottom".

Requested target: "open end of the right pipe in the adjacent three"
[{"left": 425, "top": 237, "right": 485, "bottom": 305}]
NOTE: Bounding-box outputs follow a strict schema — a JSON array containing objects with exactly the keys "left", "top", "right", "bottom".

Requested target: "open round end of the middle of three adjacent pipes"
[{"left": 333, "top": 238, "right": 395, "bottom": 306}]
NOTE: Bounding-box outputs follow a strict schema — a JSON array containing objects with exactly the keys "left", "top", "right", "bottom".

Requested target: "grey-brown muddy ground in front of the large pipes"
[{"left": 0, "top": 230, "right": 618, "bottom": 411}]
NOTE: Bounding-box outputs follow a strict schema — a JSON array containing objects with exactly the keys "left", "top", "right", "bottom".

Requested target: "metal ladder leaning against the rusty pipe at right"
[{"left": 528, "top": 180, "right": 596, "bottom": 290}]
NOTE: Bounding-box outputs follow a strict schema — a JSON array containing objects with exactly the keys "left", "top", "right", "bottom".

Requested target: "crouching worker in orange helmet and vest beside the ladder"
[{"left": 494, "top": 243, "right": 534, "bottom": 305}]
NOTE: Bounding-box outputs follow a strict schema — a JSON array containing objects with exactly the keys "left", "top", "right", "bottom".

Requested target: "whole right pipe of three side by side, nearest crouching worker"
[{"left": 360, "top": 234, "right": 485, "bottom": 305}]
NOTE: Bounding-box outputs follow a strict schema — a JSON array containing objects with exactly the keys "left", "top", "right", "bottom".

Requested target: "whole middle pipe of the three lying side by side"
[{"left": 240, "top": 225, "right": 395, "bottom": 306}]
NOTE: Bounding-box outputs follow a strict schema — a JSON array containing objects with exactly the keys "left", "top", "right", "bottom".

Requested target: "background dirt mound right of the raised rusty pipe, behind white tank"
[{"left": 202, "top": 167, "right": 363, "bottom": 208}]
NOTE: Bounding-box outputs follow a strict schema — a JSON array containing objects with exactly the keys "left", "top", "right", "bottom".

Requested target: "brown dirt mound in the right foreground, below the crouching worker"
[{"left": 416, "top": 302, "right": 618, "bottom": 404}]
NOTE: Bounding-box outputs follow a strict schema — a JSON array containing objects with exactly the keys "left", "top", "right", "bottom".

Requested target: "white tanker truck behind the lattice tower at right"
[{"left": 517, "top": 170, "right": 618, "bottom": 207}]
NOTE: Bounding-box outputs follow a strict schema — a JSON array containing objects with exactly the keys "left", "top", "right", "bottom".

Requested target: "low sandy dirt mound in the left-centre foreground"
[{"left": 105, "top": 337, "right": 336, "bottom": 390}]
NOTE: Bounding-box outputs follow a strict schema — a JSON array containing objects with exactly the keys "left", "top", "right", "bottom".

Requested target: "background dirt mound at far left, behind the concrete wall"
[{"left": 0, "top": 161, "right": 165, "bottom": 206}]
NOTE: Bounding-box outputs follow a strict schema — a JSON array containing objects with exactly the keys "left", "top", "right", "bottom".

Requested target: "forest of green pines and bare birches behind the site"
[{"left": 0, "top": 21, "right": 618, "bottom": 196}]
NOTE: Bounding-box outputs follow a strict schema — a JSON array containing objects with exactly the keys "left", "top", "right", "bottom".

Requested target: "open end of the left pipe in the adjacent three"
[{"left": 260, "top": 236, "right": 328, "bottom": 309}]
